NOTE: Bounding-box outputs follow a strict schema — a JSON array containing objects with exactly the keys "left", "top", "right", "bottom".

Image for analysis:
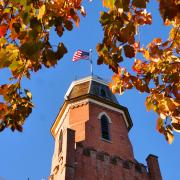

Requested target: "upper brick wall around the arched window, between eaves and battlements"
[{"left": 69, "top": 103, "right": 134, "bottom": 160}]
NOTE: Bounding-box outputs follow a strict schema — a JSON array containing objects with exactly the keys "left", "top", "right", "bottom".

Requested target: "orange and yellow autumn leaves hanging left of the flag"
[{"left": 0, "top": 0, "right": 85, "bottom": 131}]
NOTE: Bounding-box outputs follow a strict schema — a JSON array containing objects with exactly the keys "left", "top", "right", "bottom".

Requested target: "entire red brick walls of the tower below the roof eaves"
[{"left": 49, "top": 101, "right": 162, "bottom": 180}]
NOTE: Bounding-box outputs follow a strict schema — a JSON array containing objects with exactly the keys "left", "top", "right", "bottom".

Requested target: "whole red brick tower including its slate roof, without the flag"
[{"left": 49, "top": 76, "right": 162, "bottom": 180}]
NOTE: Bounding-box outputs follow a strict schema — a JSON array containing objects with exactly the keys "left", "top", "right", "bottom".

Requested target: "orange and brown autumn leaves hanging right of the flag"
[{"left": 97, "top": 0, "right": 180, "bottom": 143}]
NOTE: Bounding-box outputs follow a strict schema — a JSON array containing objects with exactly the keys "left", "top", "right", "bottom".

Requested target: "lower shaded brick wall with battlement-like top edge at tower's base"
[{"left": 74, "top": 145, "right": 149, "bottom": 180}]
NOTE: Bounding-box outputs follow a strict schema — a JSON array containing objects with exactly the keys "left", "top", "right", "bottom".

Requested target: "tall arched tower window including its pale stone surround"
[{"left": 98, "top": 112, "right": 111, "bottom": 141}]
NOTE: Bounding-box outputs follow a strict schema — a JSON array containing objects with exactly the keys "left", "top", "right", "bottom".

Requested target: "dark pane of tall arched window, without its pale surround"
[{"left": 100, "top": 115, "right": 110, "bottom": 140}]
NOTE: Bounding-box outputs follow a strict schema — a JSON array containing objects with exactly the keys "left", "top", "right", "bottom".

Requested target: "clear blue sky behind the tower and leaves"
[{"left": 0, "top": 1, "right": 180, "bottom": 180}]
